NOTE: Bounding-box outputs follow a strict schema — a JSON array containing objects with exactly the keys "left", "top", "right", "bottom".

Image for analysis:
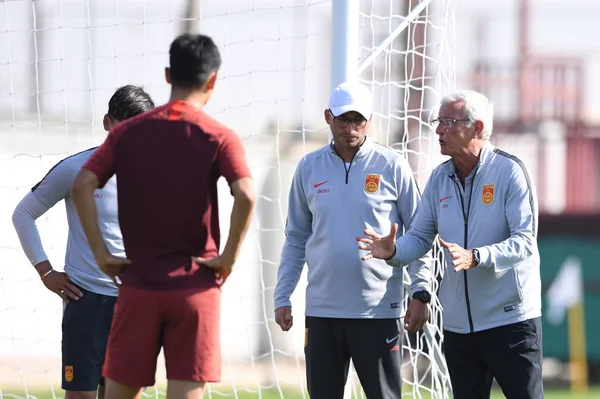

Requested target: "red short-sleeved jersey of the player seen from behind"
[{"left": 83, "top": 101, "right": 250, "bottom": 290}]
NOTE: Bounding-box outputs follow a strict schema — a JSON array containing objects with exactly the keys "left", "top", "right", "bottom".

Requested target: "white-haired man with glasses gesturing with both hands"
[{"left": 357, "top": 91, "right": 543, "bottom": 399}]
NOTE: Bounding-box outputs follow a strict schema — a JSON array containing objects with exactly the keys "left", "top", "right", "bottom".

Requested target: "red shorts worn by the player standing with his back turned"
[{"left": 103, "top": 287, "right": 221, "bottom": 387}]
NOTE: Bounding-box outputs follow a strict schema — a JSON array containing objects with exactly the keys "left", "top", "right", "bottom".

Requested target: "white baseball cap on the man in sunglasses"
[{"left": 329, "top": 81, "right": 373, "bottom": 120}]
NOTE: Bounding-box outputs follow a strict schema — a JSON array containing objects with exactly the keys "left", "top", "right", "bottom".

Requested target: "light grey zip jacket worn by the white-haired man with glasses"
[{"left": 388, "top": 142, "right": 541, "bottom": 333}]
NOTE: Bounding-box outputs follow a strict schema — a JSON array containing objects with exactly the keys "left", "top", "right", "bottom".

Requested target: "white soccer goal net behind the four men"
[{"left": 0, "top": 0, "right": 454, "bottom": 398}]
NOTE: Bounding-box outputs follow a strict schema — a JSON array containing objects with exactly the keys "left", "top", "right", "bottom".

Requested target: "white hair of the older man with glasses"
[{"left": 442, "top": 90, "right": 494, "bottom": 140}]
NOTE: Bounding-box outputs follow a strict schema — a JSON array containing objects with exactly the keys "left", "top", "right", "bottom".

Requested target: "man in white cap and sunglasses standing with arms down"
[{"left": 275, "top": 82, "right": 431, "bottom": 399}]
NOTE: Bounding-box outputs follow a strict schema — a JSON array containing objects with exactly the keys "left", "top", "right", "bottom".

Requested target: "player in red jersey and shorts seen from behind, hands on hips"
[{"left": 72, "top": 34, "right": 255, "bottom": 399}]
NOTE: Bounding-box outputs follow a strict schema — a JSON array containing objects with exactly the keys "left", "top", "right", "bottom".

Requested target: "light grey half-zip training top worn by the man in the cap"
[{"left": 275, "top": 138, "right": 431, "bottom": 318}]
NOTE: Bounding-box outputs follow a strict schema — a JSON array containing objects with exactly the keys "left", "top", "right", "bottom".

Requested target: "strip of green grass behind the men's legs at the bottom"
[{"left": 14, "top": 386, "right": 600, "bottom": 399}]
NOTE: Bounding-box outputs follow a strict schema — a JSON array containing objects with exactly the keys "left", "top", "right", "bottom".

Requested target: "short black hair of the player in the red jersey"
[{"left": 169, "top": 33, "right": 221, "bottom": 89}]
